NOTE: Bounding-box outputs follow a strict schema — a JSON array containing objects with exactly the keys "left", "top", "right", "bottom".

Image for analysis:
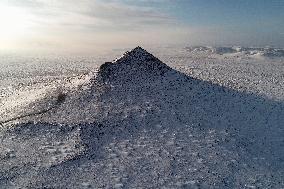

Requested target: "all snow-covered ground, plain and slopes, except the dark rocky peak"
[{"left": 0, "top": 47, "right": 284, "bottom": 188}]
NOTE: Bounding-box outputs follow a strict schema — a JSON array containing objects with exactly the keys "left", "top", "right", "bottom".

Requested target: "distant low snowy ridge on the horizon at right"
[{"left": 185, "top": 46, "right": 284, "bottom": 57}]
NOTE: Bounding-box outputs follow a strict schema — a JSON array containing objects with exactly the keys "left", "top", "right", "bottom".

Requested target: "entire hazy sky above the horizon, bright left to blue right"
[{"left": 0, "top": 0, "right": 284, "bottom": 51}]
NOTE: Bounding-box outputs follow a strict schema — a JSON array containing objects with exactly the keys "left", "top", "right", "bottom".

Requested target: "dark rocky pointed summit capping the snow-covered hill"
[{"left": 98, "top": 46, "right": 171, "bottom": 83}]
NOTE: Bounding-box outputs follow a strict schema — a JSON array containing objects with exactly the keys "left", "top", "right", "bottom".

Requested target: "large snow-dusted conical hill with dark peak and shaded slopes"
[{"left": 0, "top": 47, "right": 284, "bottom": 188}]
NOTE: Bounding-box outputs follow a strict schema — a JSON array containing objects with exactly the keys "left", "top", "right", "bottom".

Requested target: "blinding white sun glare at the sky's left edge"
[{"left": 0, "top": 5, "right": 29, "bottom": 41}]
